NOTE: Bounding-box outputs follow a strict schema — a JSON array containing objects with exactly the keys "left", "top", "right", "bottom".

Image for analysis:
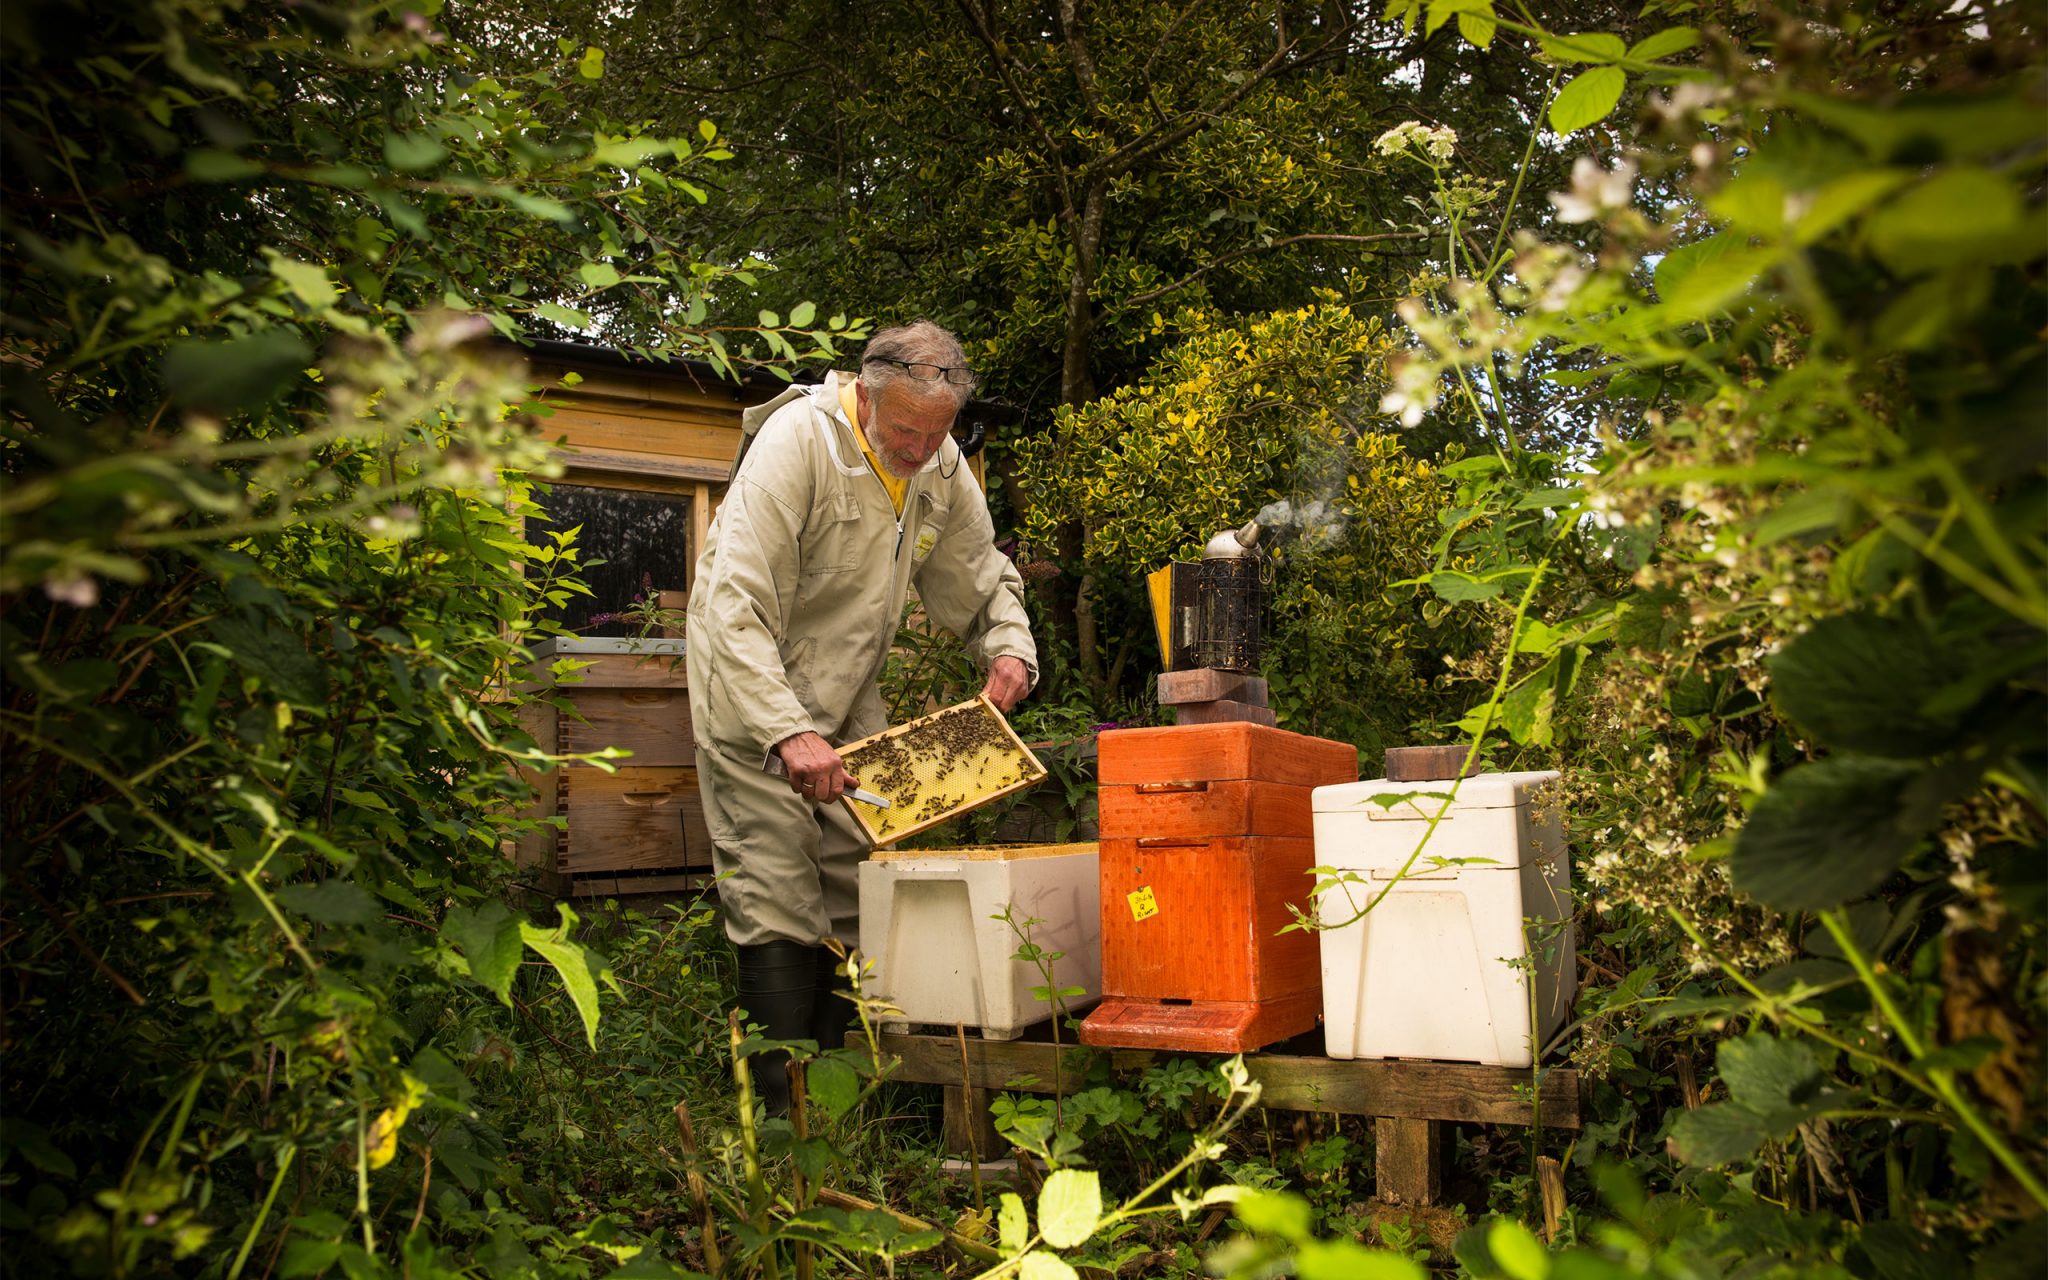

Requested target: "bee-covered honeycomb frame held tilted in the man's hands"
[{"left": 840, "top": 698, "right": 1044, "bottom": 844}]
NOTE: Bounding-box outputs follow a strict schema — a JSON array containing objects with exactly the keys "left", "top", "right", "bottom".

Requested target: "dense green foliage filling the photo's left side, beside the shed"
[{"left": 0, "top": 2, "right": 846, "bottom": 1276}]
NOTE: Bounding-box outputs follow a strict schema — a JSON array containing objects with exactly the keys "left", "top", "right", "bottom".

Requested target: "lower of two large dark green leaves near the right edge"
[{"left": 1729, "top": 756, "right": 1978, "bottom": 911}]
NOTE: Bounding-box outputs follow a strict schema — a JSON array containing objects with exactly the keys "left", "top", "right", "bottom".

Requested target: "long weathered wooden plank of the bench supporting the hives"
[{"left": 850, "top": 1034, "right": 1579, "bottom": 1128}]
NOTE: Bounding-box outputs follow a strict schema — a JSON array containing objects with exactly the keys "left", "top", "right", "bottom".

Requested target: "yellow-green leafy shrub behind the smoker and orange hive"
[{"left": 1018, "top": 305, "right": 1440, "bottom": 748}]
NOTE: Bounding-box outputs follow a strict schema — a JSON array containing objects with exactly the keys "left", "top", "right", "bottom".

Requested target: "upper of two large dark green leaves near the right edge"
[{"left": 1767, "top": 612, "right": 1968, "bottom": 760}]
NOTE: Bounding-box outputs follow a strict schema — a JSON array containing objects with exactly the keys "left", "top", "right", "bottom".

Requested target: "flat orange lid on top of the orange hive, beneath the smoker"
[{"left": 1096, "top": 721, "right": 1358, "bottom": 786}]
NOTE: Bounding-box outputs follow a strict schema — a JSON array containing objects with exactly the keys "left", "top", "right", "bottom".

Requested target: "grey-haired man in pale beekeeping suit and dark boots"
[{"left": 688, "top": 319, "right": 1036, "bottom": 1114}]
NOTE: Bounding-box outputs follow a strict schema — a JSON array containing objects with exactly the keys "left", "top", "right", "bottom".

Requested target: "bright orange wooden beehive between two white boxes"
[{"left": 1081, "top": 723, "right": 1358, "bottom": 1053}]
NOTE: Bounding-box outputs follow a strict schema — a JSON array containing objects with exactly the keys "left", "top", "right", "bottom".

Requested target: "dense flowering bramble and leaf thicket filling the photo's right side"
[{"left": 1380, "top": 0, "right": 2048, "bottom": 1245}]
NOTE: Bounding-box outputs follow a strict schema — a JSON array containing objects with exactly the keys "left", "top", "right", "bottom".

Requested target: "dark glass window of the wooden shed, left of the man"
[{"left": 526, "top": 483, "right": 692, "bottom": 635}]
